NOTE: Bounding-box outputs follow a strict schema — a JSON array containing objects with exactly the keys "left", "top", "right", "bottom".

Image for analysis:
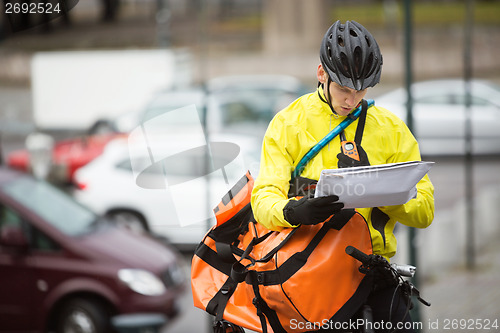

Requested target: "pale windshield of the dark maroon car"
[{"left": 3, "top": 178, "right": 97, "bottom": 236}]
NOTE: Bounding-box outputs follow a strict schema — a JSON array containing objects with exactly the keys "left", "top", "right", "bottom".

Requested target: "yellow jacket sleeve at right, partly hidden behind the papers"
[{"left": 379, "top": 119, "right": 434, "bottom": 228}]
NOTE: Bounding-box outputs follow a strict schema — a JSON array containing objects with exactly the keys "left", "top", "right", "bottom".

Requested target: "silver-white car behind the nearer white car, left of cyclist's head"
[{"left": 110, "top": 75, "right": 308, "bottom": 137}]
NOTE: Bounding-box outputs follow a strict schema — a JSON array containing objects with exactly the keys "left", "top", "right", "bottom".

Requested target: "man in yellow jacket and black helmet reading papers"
[{"left": 251, "top": 21, "right": 434, "bottom": 332}]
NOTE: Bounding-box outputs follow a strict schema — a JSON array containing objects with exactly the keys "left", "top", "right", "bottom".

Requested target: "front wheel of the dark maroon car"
[{"left": 56, "top": 298, "right": 110, "bottom": 333}]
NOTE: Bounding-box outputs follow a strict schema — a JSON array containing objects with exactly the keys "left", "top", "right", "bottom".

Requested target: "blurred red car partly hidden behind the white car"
[{"left": 7, "top": 133, "right": 125, "bottom": 183}]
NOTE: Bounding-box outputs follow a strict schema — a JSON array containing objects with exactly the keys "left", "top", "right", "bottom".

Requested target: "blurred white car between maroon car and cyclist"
[{"left": 73, "top": 134, "right": 261, "bottom": 250}]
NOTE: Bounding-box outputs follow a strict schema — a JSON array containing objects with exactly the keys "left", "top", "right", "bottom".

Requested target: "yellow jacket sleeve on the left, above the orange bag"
[{"left": 251, "top": 118, "right": 299, "bottom": 231}]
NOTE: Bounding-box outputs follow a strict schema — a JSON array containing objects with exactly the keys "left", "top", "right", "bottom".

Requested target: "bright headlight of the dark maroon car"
[{"left": 118, "top": 269, "right": 166, "bottom": 296}]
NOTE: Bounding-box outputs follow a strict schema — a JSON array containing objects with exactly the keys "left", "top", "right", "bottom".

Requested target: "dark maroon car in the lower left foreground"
[{"left": 0, "top": 167, "right": 186, "bottom": 333}]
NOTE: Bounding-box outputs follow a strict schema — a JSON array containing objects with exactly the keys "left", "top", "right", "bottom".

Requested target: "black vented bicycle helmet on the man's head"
[{"left": 320, "top": 21, "right": 382, "bottom": 90}]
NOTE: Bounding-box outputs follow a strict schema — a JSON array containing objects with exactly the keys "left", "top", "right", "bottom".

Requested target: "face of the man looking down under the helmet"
[{"left": 317, "top": 64, "right": 367, "bottom": 116}]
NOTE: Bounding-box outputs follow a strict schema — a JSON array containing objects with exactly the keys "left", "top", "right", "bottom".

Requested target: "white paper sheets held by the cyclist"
[{"left": 315, "top": 161, "right": 434, "bottom": 208}]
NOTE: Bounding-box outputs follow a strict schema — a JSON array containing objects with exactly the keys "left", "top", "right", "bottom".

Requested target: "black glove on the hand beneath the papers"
[{"left": 283, "top": 195, "right": 344, "bottom": 225}]
